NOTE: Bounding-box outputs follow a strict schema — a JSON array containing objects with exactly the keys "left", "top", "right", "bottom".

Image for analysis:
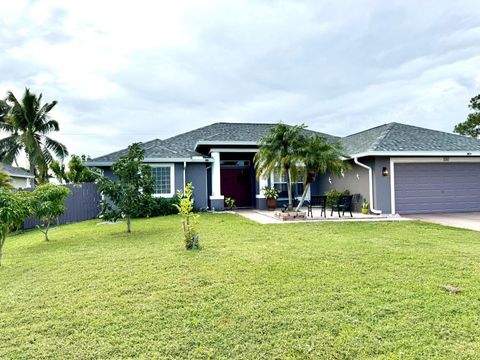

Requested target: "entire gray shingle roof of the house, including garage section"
[{"left": 90, "top": 123, "right": 480, "bottom": 163}]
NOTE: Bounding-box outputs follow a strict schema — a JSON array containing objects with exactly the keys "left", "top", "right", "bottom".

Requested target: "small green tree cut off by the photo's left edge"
[{"left": 0, "top": 189, "right": 30, "bottom": 265}]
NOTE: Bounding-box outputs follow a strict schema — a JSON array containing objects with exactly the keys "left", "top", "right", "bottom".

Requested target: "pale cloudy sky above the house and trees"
[{"left": 0, "top": 0, "right": 480, "bottom": 157}]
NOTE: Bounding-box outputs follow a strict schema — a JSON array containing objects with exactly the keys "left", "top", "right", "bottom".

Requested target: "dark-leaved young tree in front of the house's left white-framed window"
[{"left": 97, "top": 143, "right": 154, "bottom": 232}]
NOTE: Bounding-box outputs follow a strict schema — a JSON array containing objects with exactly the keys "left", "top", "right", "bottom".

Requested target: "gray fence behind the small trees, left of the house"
[{"left": 22, "top": 183, "right": 100, "bottom": 230}]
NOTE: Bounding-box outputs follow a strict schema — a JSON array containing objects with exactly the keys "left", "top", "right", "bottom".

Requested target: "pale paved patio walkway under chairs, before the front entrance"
[{"left": 235, "top": 208, "right": 410, "bottom": 224}]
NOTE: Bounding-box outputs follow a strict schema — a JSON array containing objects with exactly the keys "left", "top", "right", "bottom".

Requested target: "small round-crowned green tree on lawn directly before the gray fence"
[{"left": 32, "top": 184, "right": 70, "bottom": 241}]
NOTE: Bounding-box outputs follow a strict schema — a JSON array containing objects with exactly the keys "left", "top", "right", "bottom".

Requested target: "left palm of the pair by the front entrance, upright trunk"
[{"left": 254, "top": 123, "right": 306, "bottom": 211}]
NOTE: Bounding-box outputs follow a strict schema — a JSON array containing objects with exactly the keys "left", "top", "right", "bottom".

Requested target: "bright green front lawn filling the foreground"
[{"left": 0, "top": 214, "right": 480, "bottom": 359}]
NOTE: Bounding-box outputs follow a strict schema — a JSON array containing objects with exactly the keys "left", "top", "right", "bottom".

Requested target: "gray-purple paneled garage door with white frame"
[{"left": 394, "top": 163, "right": 480, "bottom": 214}]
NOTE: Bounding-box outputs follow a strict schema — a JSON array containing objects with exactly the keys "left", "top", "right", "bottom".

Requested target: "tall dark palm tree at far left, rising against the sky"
[{"left": 0, "top": 89, "right": 68, "bottom": 183}]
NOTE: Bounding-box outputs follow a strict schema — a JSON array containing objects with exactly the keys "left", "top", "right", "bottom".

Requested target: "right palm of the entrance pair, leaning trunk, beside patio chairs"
[{"left": 295, "top": 135, "right": 350, "bottom": 211}]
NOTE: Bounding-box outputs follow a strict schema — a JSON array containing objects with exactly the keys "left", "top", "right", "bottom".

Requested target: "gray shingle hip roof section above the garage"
[{"left": 341, "top": 122, "right": 480, "bottom": 155}]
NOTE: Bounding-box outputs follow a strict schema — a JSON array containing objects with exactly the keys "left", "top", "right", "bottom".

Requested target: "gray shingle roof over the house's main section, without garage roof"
[{"left": 87, "top": 122, "right": 340, "bottom": 166}]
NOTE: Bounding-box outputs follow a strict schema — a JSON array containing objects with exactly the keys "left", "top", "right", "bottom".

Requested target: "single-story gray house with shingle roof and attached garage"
[{"left": 87, "top": 123, "right": 480, "bottom": 214}]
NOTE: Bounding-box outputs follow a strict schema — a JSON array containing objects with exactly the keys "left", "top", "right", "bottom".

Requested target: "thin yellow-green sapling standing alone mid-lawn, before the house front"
[{"left": 174, "top": 183, "right": 200, "bottom": 250}]
